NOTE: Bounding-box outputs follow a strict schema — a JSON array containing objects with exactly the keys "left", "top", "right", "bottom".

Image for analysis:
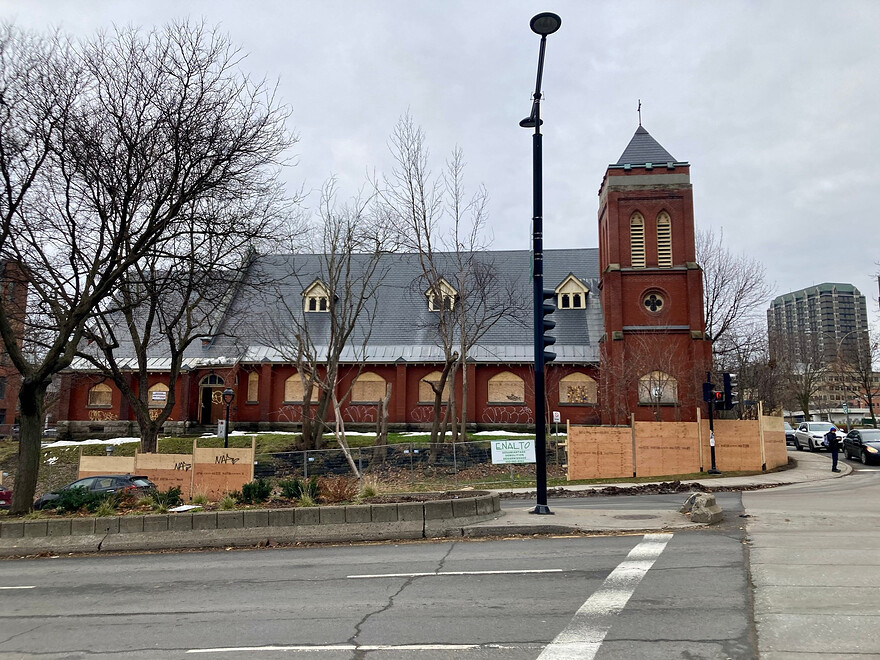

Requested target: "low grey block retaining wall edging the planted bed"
[{"left": 0, "top": 494, "right": 501, "bottom": 556}]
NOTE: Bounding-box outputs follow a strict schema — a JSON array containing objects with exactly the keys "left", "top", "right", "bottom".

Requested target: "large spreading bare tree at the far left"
[{"left": 0, "top": 23, "right": 291, "bottom": 513}]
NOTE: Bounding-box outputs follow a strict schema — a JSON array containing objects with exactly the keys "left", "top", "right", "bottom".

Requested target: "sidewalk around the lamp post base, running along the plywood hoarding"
[{"left": 470, "top": 451, "right": 852, "bottom": 536}]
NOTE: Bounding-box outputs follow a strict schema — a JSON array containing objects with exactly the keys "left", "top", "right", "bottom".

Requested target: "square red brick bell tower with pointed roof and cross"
[{"left": 599, "top": 124, "right": 712, "bottom": 424}]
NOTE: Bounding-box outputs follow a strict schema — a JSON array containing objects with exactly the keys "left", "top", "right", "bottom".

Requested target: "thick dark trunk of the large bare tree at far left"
[{"left": 9, "top": 378, "right": 50, "bottom": 515}]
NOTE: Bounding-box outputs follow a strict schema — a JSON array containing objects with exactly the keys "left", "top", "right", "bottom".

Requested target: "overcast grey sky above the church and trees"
[{"left": 6, "top": 0, "right": 880, "bottom": 321}]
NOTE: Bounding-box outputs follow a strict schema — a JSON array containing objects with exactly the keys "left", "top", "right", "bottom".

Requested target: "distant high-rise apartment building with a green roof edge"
[{"left": 767, "top": 282, "right": 868, "bottom": 366}]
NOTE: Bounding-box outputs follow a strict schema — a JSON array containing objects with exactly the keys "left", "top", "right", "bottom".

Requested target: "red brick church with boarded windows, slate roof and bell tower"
[{"left": 53, "top": 126, "right": 711, "bottom": 437}]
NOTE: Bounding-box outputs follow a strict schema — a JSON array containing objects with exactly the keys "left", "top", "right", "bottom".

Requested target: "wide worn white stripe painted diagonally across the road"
[{"left": 538, "top": 534, "right": 672, "bottom": 660}]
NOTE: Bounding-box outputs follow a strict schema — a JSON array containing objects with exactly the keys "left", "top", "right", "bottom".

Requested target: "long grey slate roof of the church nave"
[{"left": 72, "top": 248, "right": 603, "bottom": 371}]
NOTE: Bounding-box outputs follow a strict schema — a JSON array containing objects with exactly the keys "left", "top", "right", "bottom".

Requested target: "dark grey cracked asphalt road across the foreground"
[{"left": 0, "top": 524, "right": 756, "bottom": 660}]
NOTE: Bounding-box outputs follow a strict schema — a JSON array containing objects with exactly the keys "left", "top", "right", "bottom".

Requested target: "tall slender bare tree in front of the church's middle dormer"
[{"left": 376, "top": 115, "right": 520, "bottom": 448}]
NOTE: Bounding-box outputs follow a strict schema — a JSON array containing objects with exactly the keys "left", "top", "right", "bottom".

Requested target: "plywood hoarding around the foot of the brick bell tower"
[{"left": 568, "top": 414, "right": 788, "bottom": 481}]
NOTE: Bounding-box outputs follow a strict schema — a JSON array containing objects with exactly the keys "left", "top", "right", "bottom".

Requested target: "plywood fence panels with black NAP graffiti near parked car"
[{"left": 79, "top": 441, "right": 254, "bottom": 499}]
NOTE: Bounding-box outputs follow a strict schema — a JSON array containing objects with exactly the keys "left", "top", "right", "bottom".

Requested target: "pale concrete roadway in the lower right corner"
[{"left": 743, "top": 446, "right": 880, "bottom": 660}]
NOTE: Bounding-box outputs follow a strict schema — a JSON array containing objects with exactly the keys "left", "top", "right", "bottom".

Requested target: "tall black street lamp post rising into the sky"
[{"left": 519, "top": 12, "right": 562, "bottom": 514}]
